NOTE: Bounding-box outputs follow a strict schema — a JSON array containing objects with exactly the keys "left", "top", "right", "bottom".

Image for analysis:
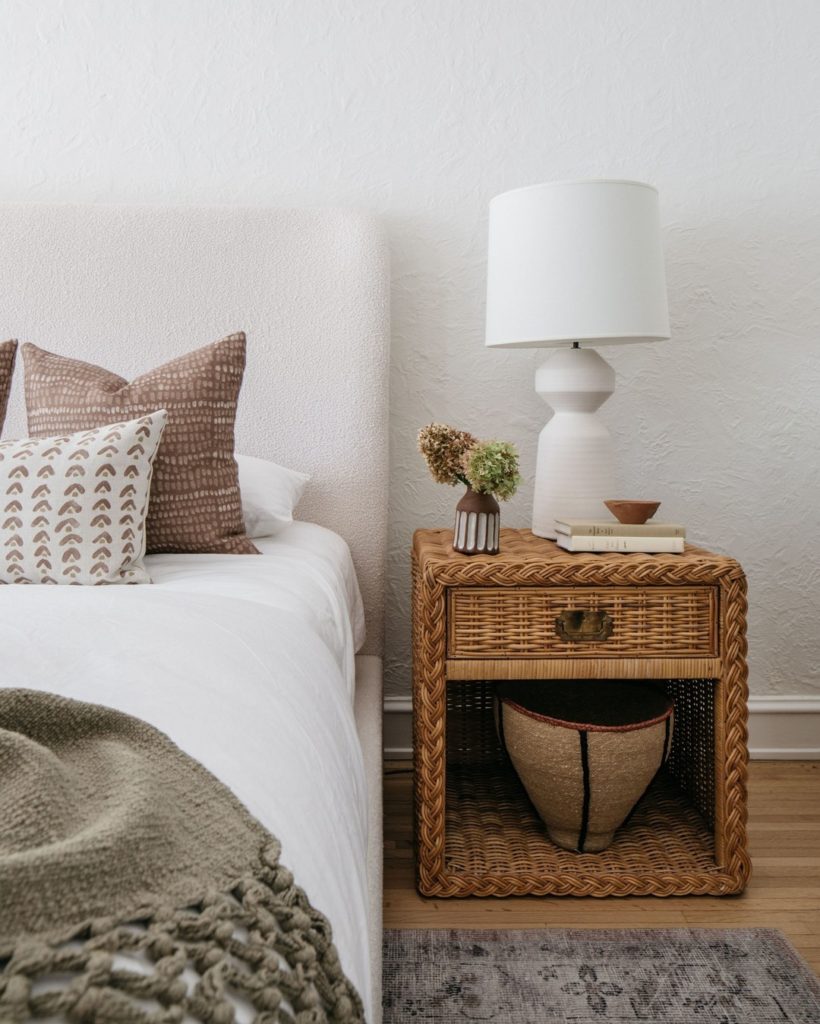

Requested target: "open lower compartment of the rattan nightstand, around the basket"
[{"left": 444, "top": 680, "right": 724, "bottom": 895}]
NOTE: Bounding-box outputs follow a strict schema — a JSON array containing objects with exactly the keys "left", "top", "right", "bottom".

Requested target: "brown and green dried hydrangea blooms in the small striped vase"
[{"left": 419, "top": 423, "right": 521, "bottom": 501}]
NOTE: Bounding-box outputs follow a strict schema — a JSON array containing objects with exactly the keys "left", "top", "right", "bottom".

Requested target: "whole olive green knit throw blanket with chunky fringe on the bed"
[{"left": 0, "top": 689, "right": 363, "bottom": 1024}]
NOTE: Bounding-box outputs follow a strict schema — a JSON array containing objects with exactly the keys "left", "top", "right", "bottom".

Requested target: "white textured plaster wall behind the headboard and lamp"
[{"left": 0, "top": 0, "right": 820, "bottom": 693}]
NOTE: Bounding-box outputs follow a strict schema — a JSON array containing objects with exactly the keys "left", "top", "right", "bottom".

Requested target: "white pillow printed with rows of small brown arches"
[{"left": 0, "top": 410, "right": 167, "bottom": 584}]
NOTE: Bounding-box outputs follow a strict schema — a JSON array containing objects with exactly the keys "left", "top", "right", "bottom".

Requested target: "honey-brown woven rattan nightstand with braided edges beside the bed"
[{"left": 413, "top": 529, "right": 750, "bottom": 896}]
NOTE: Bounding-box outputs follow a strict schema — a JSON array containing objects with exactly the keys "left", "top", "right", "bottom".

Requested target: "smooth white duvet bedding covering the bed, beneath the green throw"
[{"left": 0, "top": 522, "right": 371, "bottom": 1019}]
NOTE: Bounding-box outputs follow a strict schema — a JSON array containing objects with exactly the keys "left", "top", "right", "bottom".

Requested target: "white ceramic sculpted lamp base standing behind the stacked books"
[{"left": 532, "top": 348, "right": 617, "bottom": 540}]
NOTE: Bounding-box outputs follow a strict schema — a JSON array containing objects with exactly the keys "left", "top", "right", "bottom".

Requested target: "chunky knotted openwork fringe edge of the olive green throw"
[{"left": 0, "top": 841, "right": 364, "bottom": 1024}]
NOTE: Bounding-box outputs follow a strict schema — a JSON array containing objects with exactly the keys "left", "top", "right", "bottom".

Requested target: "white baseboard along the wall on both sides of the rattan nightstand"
[{"left": 384, "top": 695, "right": 820, "bottom": 761}]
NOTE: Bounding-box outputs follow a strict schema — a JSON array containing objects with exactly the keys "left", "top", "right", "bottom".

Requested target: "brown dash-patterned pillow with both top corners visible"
[{"left": 23, "top": 334, "right": 257, "bottom": 554}]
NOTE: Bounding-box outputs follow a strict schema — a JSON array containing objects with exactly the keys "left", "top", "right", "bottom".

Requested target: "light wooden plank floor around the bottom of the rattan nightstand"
[{"left": 384, "top": 761, "right": 820, "bottom": 974}]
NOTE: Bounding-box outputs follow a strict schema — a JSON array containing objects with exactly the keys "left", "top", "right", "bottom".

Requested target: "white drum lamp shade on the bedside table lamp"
[{"left": 486, "top": 180, "right": 670, "bottom": 348}]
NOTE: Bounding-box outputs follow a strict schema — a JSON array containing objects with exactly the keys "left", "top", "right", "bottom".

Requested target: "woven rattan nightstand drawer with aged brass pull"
[{"left": 447, "top": 586, "right": 718, "bottom": 658}]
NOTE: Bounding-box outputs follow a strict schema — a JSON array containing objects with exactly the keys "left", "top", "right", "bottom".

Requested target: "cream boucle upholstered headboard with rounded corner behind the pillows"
[{"left": 0, "top": 206, "right": 389, "bottom": 653}]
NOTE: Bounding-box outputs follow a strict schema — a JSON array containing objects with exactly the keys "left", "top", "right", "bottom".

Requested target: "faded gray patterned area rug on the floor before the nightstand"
[{"left": 384, "top": 929, "right": 820, "bottom": 1024}]
